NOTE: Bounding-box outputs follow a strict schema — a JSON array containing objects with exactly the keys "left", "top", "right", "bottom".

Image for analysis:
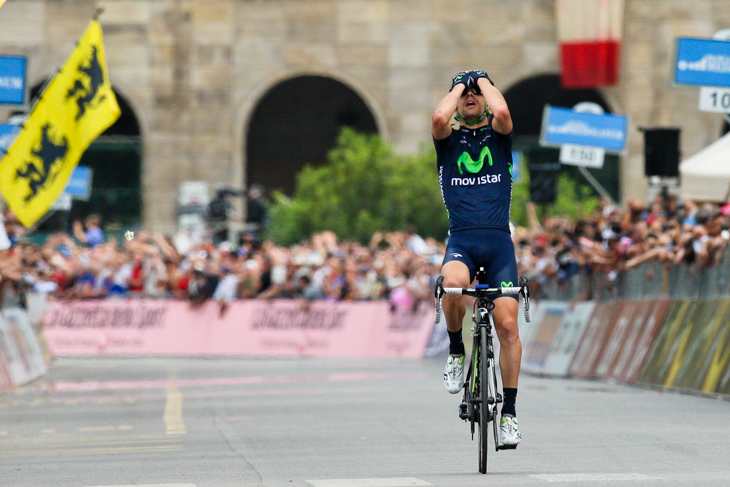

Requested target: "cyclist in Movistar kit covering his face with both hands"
[{"left": 431, "top": 70, "right": 522, "bottom": 445}]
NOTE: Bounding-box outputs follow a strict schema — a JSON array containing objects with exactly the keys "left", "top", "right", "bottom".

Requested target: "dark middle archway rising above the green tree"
[{"left": 246, "top": 75, "right": 377, "bottom": 195}]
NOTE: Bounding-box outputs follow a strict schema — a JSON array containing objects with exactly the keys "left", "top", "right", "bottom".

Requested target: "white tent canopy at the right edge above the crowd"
[{"left": 679, "top": 133, "right": 730, "bottom": 202}]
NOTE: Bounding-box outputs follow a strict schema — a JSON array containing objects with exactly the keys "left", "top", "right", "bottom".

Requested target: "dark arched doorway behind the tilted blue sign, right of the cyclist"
[{"left": 504, "top": 74, "right": 621, "bottom": 201}]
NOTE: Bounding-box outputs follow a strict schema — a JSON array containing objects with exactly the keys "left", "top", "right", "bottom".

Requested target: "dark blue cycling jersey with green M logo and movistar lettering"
[{"left": 433, "top": 125, "right": 512, "bottom": 232}]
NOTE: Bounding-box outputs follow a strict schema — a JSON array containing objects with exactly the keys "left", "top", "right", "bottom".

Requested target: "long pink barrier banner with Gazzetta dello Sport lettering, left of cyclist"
[{"left": 43, "top": 299, "right": 433, "bottom": 358}]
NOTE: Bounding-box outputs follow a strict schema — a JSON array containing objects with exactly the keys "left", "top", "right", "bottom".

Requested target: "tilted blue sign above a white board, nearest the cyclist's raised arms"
[{"left": 540, "top": 105, "right": 629, "bottom": 152}]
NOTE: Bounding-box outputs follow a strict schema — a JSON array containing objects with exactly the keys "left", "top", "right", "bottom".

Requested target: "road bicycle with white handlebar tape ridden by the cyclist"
[{"left": 434, "top": 267, "right": 530, "bottom": 473}]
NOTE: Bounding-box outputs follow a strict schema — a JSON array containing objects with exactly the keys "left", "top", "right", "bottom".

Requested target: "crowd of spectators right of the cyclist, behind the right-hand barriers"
[{"left": 513, "top": 192, "right": 730, "bottom": 298}]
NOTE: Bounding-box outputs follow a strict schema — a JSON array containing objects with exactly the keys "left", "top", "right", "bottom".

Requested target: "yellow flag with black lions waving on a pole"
[{"left": 0, "top": 20, "right": 121, "bottom": 227}]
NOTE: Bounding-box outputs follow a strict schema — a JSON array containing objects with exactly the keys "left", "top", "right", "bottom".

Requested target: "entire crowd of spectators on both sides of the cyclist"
[{"left": 0, "top": 194, "right": 730, "bottom": 312}]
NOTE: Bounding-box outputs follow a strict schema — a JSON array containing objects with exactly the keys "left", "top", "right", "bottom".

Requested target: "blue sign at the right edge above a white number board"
[{"left": 674, "top": 37, "right": 730, "bottom": 86}]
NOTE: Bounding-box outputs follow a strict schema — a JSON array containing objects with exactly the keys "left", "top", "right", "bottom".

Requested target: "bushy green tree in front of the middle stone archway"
[{"left": 267, "top": 128, "right": 448, "bottom": 244}]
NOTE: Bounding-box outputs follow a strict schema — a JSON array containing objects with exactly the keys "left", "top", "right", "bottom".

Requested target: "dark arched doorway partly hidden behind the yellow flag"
[{"left": 19, "top": 81, "right": 142, "bottom": 232}]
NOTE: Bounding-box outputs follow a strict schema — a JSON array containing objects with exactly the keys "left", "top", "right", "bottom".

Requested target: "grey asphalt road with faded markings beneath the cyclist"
[{"left": 0, "top": 358, "right": 730, "bottom": 487}]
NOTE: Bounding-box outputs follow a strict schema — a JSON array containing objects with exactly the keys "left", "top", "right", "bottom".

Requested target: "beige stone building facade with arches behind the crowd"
[{"left": 0, "top": 0, "right": 730, "bottom": 231}]
